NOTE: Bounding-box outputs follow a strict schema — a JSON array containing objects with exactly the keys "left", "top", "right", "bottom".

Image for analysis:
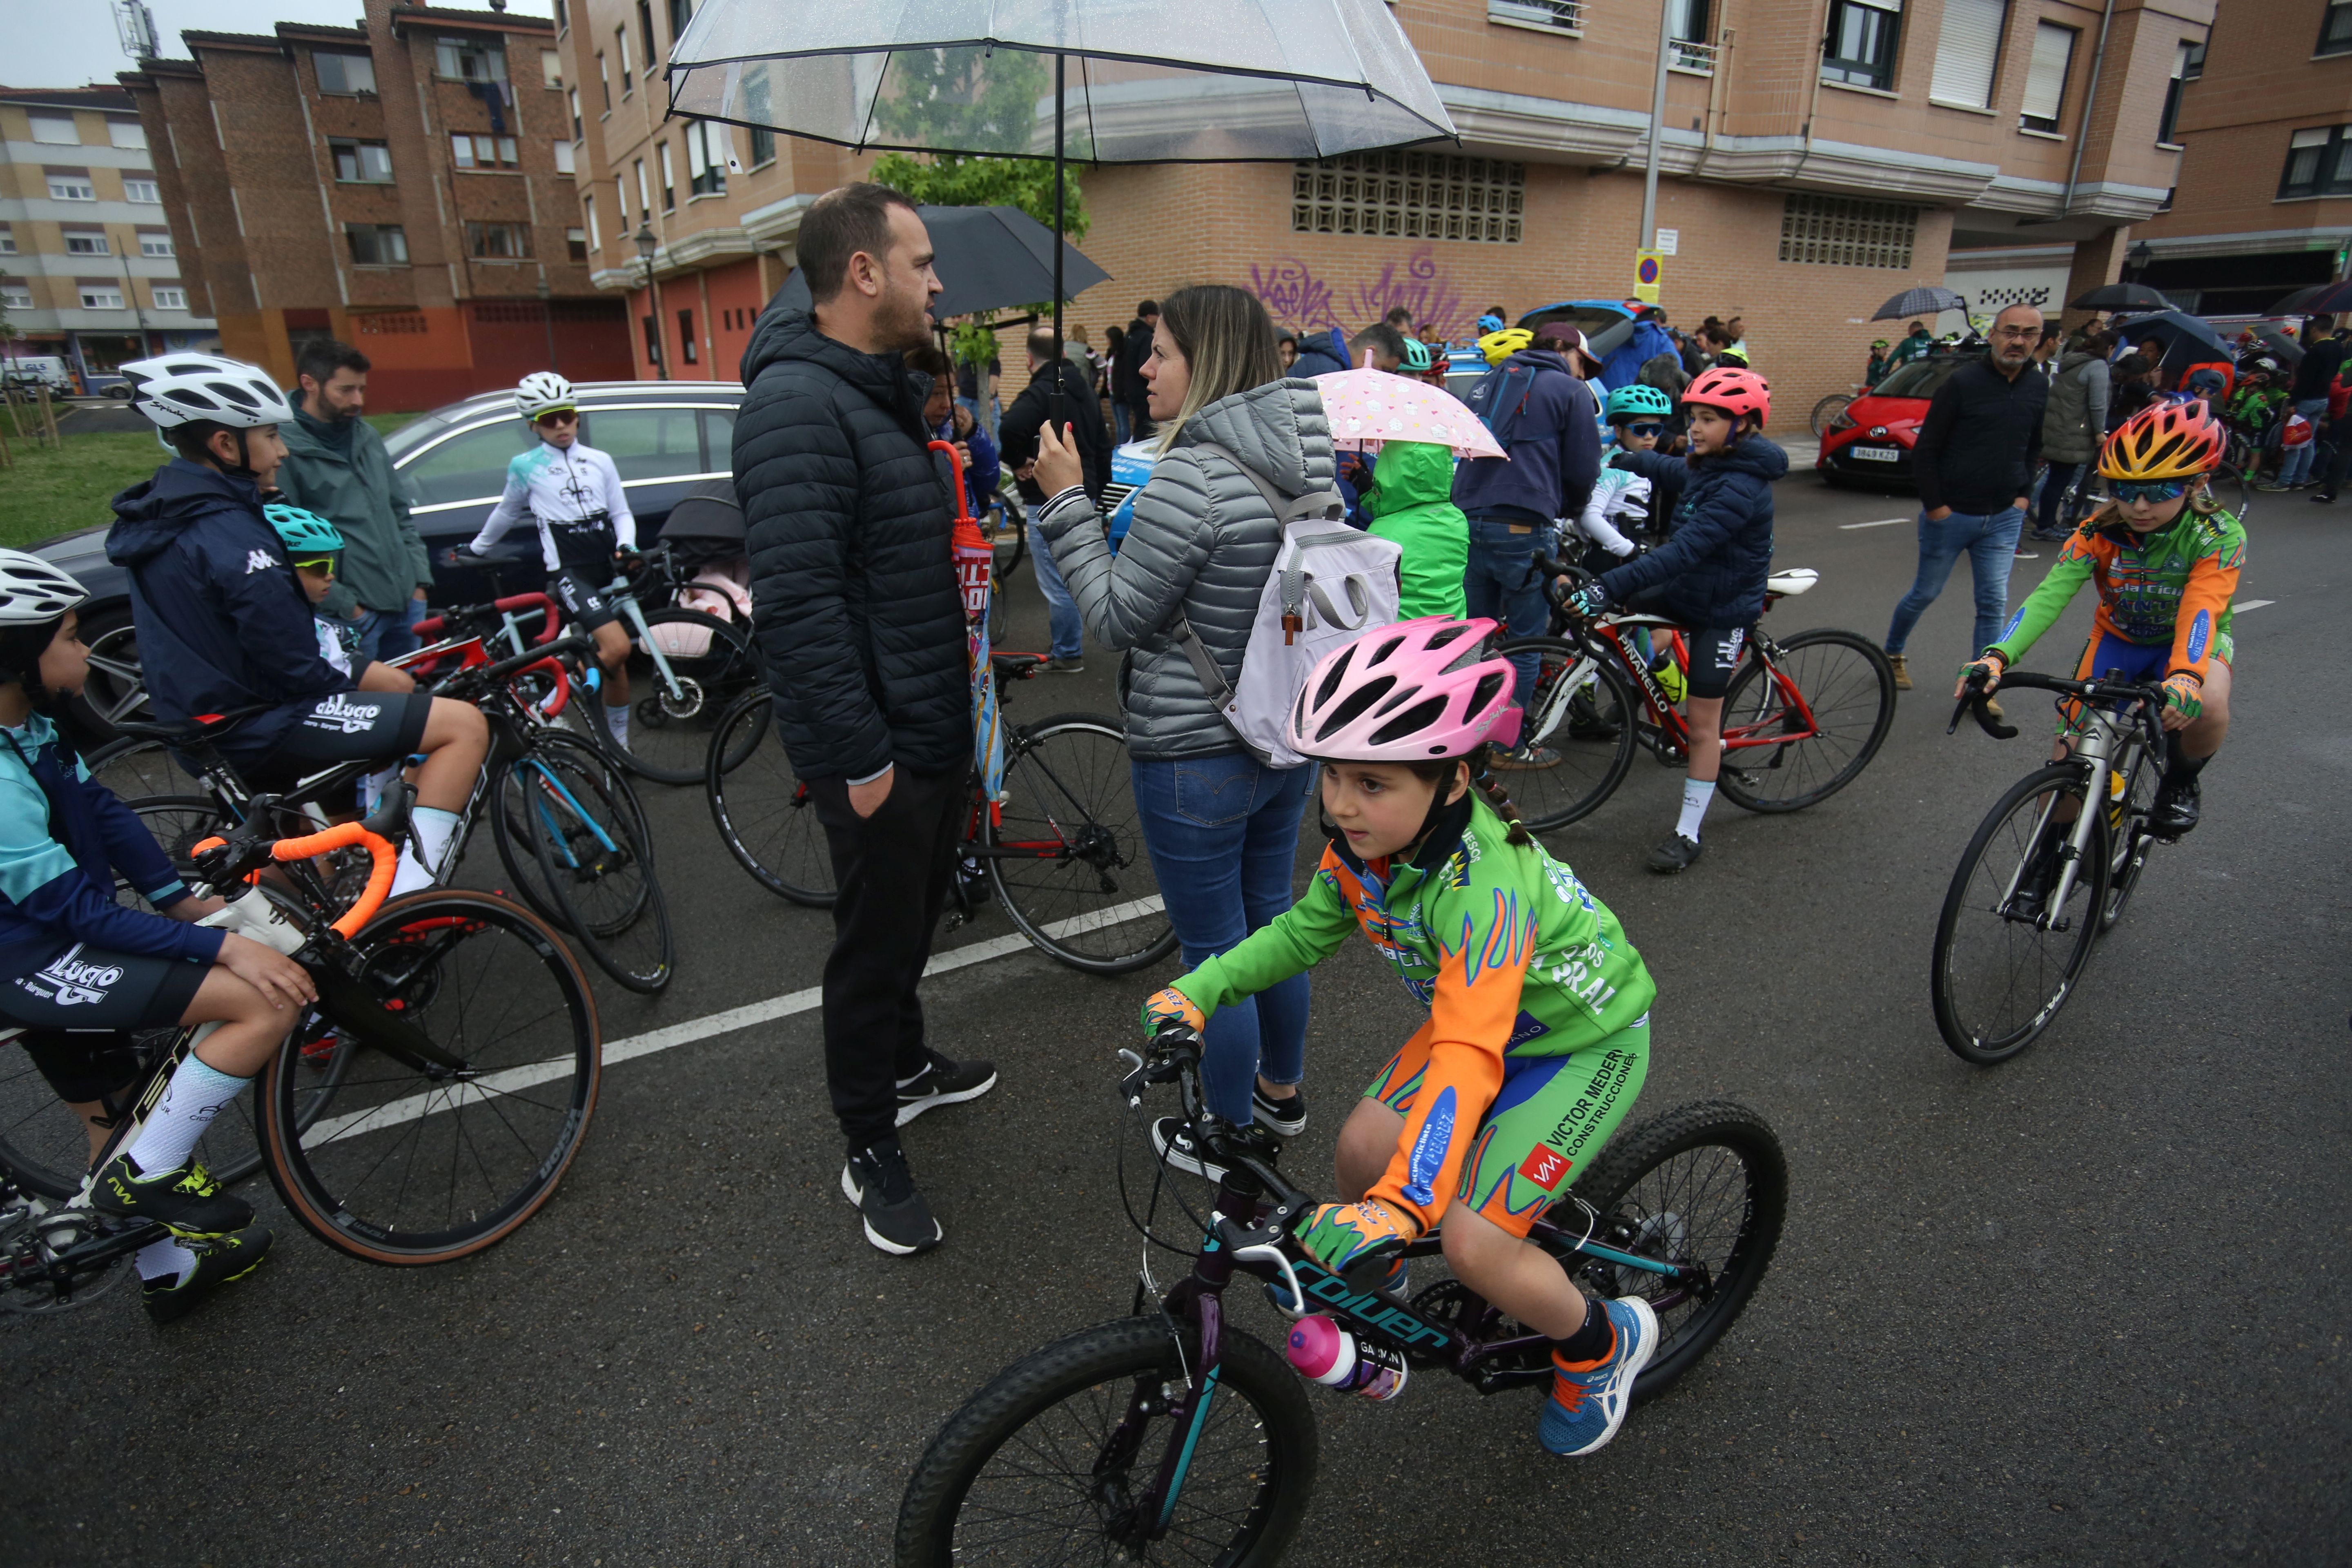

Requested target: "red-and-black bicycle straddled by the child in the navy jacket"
[{"left": 1498, "top": 555, "right": 1896, "bottom": 832}]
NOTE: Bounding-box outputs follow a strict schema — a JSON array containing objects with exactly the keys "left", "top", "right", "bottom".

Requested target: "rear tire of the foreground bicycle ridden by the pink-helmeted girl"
[{"left": 1552, "top": 1100, "right": 1788, "bottom": 1403}]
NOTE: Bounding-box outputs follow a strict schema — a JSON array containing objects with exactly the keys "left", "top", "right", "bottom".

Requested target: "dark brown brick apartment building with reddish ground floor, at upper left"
[{"left": 120, "top": 0, "right": 633, "bottom": 409}]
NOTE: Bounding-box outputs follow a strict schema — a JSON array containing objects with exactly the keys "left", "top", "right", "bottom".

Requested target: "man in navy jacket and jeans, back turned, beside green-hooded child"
[{"left": 1454, "top": 322, "right": 1602, "bottom": 766}]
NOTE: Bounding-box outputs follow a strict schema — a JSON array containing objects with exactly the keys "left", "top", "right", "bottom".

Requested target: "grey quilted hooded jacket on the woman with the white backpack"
[{"left": 1035, "top": 376, "right": 1331, "bottom": 762}]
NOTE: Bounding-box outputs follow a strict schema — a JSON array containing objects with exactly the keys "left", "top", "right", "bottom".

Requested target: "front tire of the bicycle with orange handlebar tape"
[{"left": 256, "top": 889, "right": 604, "bottom": 1267}]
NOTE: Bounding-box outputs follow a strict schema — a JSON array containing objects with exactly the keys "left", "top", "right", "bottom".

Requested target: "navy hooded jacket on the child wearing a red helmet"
[{"left": 1602, "top": 435, "right": 1788, "bottom": 630}]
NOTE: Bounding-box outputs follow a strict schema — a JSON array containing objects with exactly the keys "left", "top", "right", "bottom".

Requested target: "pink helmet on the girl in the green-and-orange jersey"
[{"left": 1291, "top": 616, "right": 1519, "bottom": 762}]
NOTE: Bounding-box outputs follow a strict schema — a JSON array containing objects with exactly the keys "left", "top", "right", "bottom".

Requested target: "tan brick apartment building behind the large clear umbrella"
[{"left": 560, "top": 0, "right": 2201, "bottom": 407}]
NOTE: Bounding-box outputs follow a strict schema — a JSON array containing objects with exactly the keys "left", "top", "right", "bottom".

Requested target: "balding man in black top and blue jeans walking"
[{"left": 1886, "top": 305, "right": 2051, "bottom": 710}]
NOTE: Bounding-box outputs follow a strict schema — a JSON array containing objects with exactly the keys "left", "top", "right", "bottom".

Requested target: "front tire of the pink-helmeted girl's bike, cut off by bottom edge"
[{"left": 894, "top": 1316, "right": 1317, "bottom": 1568}]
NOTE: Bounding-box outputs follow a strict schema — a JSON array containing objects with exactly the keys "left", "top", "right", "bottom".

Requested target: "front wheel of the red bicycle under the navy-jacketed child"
[{"left": 1491, "top": 637, "right": 1642, "bottom": 832}]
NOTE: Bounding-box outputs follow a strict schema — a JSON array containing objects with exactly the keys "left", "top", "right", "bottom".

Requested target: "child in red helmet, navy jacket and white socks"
[{"left": 1569, "top": 367, "right": 1788, "bottom": 875}]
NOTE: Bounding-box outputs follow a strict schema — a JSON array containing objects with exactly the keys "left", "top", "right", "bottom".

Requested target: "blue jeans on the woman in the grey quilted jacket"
[{"left": 1131, "top": 755, "right": 1315, "bottom": 1126}]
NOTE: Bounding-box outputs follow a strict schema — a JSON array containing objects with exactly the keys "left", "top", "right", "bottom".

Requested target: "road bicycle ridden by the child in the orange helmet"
[{"left": 1929, "top": 670, "right": 2171, "bottom": 1067}]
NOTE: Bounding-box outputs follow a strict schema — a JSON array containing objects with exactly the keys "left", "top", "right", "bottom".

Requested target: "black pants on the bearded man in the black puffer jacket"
[{"left": 809, "top": 766, "right": 971, "bottom": 1149}]
